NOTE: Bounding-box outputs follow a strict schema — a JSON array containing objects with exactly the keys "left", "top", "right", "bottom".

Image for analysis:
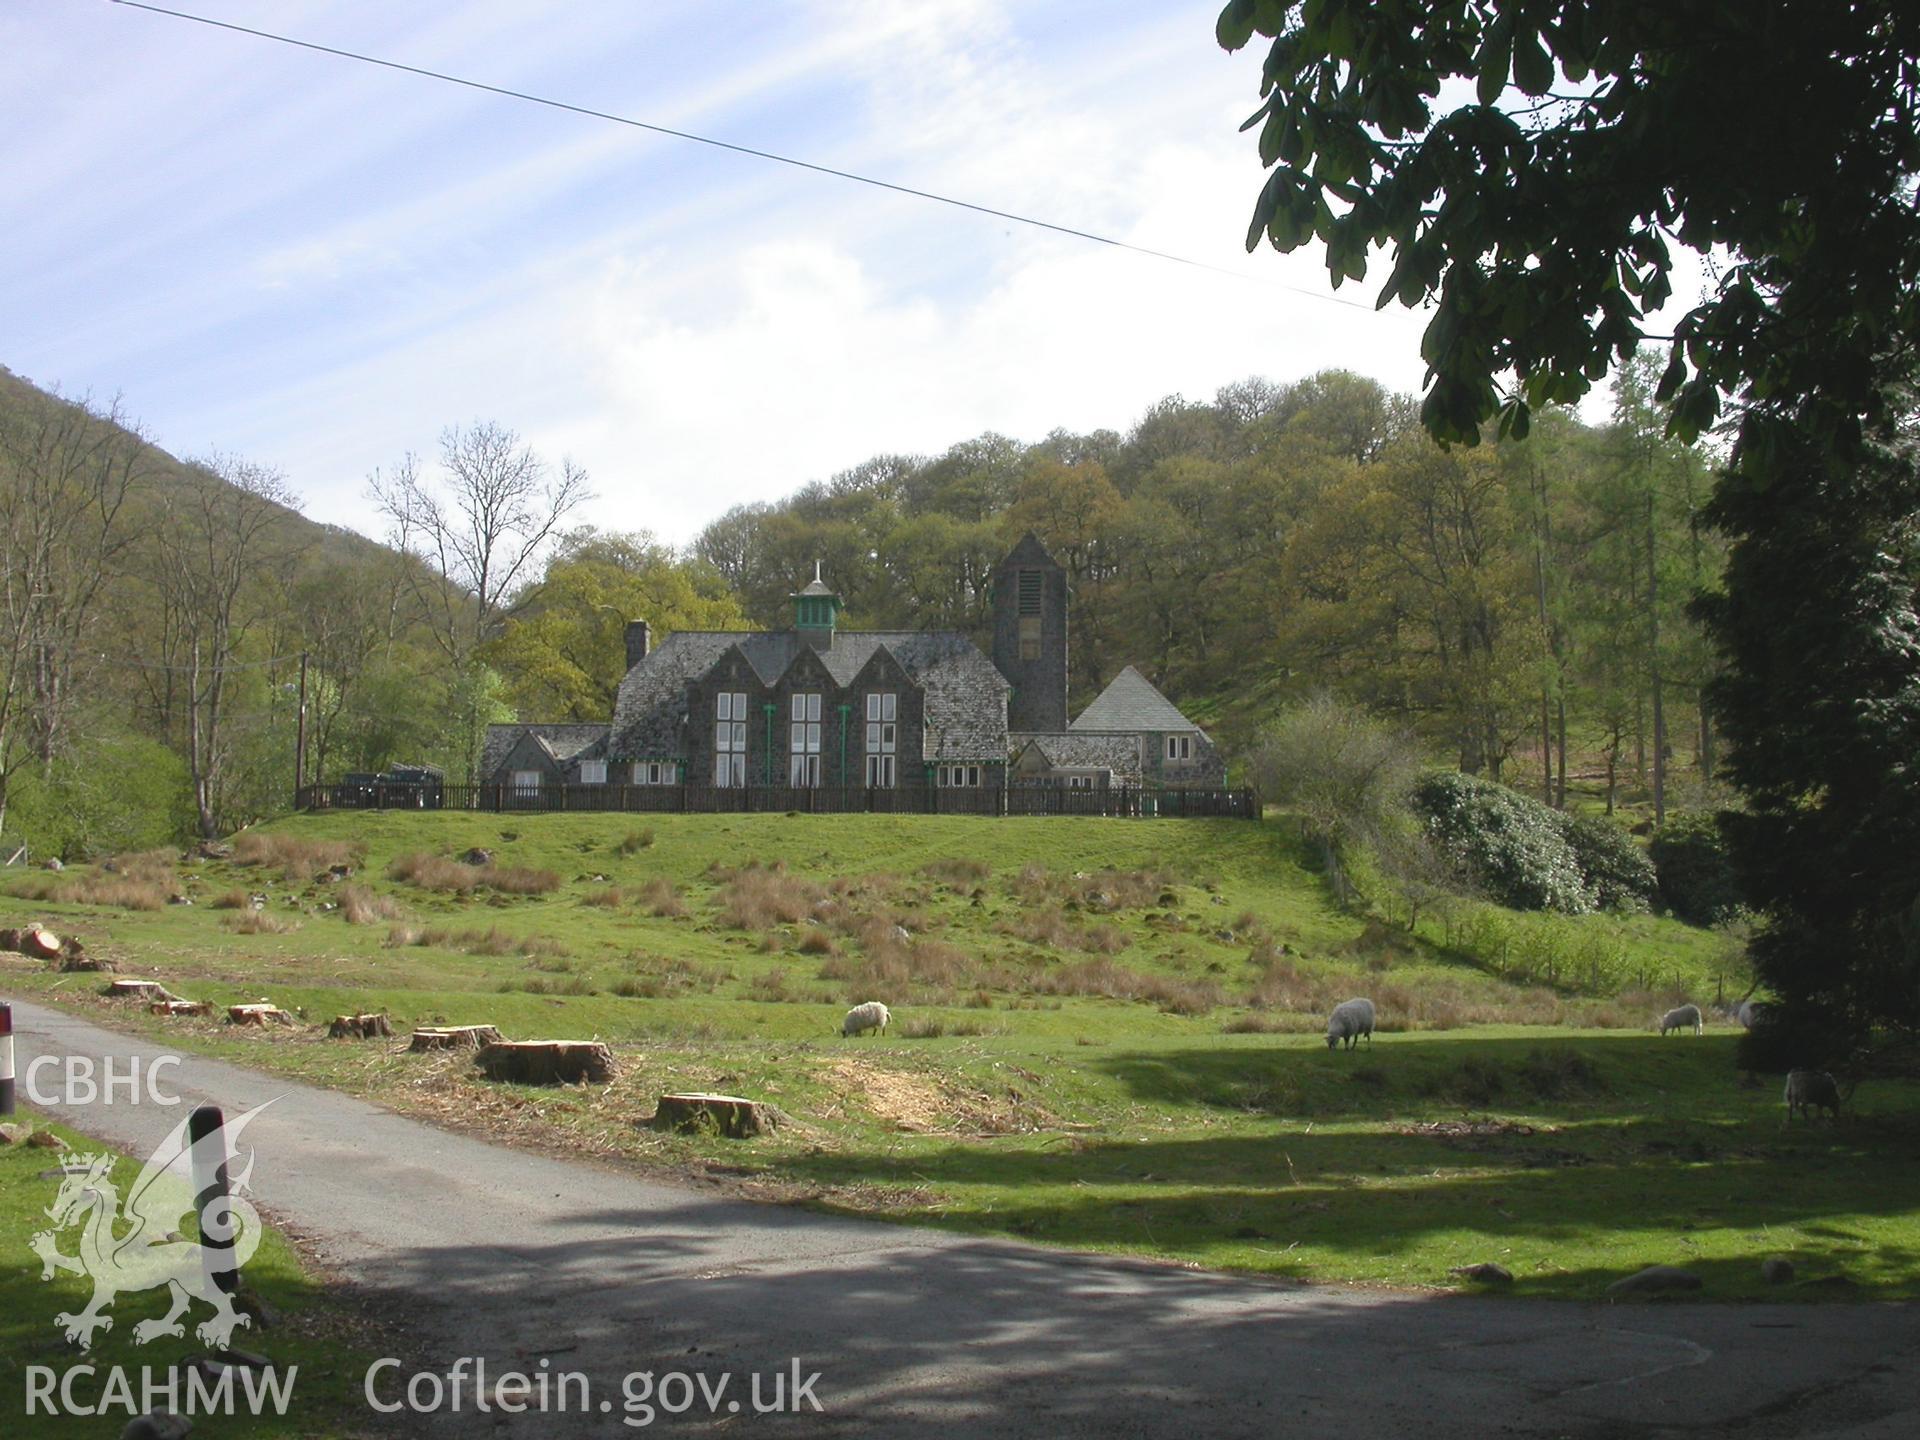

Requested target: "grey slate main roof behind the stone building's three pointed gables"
[{"left": 611, "top": 630, "right": 1012, "bottom": 760}]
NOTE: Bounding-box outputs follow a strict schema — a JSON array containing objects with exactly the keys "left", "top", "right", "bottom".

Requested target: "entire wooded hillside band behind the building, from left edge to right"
[{"left": 0, "top": 360, "right": 1720, "bottom": 856}]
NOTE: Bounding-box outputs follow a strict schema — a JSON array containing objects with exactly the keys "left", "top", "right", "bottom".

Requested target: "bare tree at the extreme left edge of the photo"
[{"left": 0, "top": 396, "right": 150, "bottom": 840}]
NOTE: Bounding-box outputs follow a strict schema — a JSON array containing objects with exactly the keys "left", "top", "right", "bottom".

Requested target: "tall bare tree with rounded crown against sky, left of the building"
[{"left": 367, "top": 420, "right": 593, "bottom": 778}]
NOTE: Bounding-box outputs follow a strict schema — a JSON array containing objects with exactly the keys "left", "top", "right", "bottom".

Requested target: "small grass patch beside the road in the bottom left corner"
[{"left": 0, "top": 1116, "right": 378, "bottom": 1440}]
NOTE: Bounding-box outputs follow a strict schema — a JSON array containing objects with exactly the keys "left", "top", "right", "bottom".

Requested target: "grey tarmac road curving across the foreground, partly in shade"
[{"left": 13, "top": 1002, "right": 1920, "bottom": 1440}]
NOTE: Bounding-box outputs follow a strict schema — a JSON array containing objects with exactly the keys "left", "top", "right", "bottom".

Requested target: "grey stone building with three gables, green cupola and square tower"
[{"left": 480, "top": 534, "right": 1223, "bottom": 791}]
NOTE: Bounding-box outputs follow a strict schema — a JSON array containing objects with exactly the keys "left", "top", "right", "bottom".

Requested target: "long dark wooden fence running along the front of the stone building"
[{"left": 294, "top": 783, "right": 1260, "bottom": 820}]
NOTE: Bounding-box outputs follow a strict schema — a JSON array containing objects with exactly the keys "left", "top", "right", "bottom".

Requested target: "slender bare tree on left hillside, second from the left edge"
[{"left": 154, "top": 455, "right": 298, "bottom": 835}]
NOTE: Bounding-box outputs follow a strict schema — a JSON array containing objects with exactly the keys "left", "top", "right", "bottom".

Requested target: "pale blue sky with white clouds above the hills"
[{"left": 0, "top": 0, "right": 1423, "bottom": 541}]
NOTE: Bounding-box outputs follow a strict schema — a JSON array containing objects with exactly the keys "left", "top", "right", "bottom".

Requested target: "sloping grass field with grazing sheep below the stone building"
[{"left": 0, "top": 814, "right": 1920, "bottom": 1298}]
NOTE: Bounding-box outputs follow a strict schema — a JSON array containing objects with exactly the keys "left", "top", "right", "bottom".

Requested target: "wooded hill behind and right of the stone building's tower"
[{"left": 695, "top": 369, "right": 1722, "bottom": 814}]
